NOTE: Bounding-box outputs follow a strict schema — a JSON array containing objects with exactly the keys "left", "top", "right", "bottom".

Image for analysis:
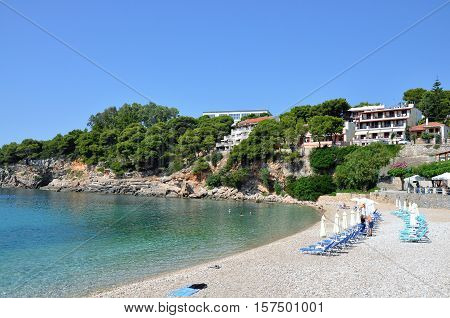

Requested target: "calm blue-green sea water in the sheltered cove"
[{"left": 0, "top": 189, "right": 318, "bottom": 297}]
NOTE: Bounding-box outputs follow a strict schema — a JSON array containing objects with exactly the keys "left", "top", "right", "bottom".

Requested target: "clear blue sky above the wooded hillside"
[{"left": 0, "top": 0, "right": 450, "bottom": 144}]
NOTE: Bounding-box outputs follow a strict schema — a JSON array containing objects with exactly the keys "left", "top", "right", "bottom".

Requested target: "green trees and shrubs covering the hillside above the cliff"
[{"left": 0, "top": 82, "right": 450, "bottom": 200}]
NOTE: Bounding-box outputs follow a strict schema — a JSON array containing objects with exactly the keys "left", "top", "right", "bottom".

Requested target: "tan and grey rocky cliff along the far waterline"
[{"left": 0, "top": 160, "right": 313, "bottom": 204}]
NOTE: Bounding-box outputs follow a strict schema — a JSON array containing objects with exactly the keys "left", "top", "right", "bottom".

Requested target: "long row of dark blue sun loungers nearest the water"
[{"left": 300, "top": 211, "right": 381, "bottom": 255}]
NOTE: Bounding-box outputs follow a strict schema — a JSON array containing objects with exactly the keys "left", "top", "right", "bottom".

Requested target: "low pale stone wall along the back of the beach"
[{"left": 370, "top": 191, "right": 450, "bottom": 212}]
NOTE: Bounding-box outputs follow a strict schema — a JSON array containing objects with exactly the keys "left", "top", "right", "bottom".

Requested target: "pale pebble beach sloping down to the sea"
[{"left": 95, "top": 202, "right": 450, "bottom": 298}]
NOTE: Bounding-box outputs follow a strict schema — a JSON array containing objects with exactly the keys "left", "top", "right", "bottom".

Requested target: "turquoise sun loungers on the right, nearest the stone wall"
[{"left": 393, "top": 209, "right": 430, "bottom": 242}]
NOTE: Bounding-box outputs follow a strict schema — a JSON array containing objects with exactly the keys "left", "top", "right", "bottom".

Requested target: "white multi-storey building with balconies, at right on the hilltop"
[{"left": 349, "top": 104, "right": 422, "bottom": 145}]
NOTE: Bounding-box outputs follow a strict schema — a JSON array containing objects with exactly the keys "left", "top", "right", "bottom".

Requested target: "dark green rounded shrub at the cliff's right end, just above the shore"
[{"left": 285, "top": 175, "right": 336, "bottom": 201}]
